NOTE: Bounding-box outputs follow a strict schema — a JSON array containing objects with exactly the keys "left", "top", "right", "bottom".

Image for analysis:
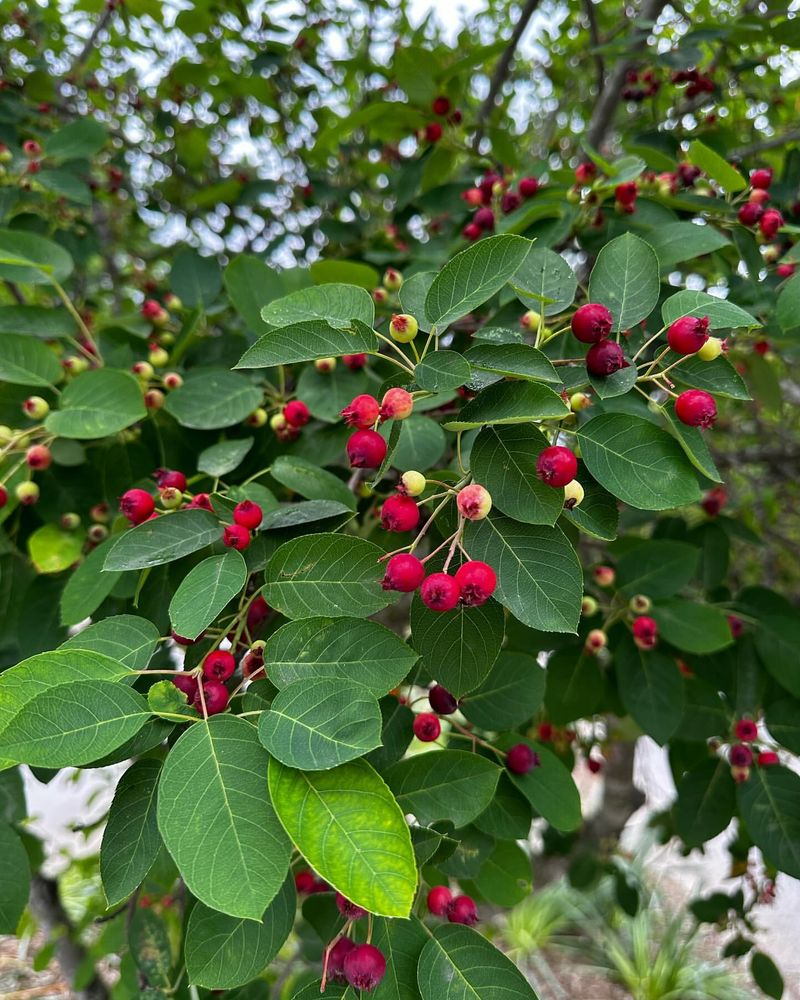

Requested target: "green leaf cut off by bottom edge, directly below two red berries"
[{"left": 417, "top": 924, "right": 537, "bottom": 1000}]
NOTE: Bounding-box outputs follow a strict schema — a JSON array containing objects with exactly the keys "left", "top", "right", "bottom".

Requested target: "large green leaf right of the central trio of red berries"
[{"left": 465, "top": 517, "right": 583, "bottom": 632}]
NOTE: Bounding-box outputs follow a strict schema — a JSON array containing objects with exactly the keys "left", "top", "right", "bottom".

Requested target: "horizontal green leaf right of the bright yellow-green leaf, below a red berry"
[{"left": 386, "top": 750, "right": 502, "bottom": 829}]
